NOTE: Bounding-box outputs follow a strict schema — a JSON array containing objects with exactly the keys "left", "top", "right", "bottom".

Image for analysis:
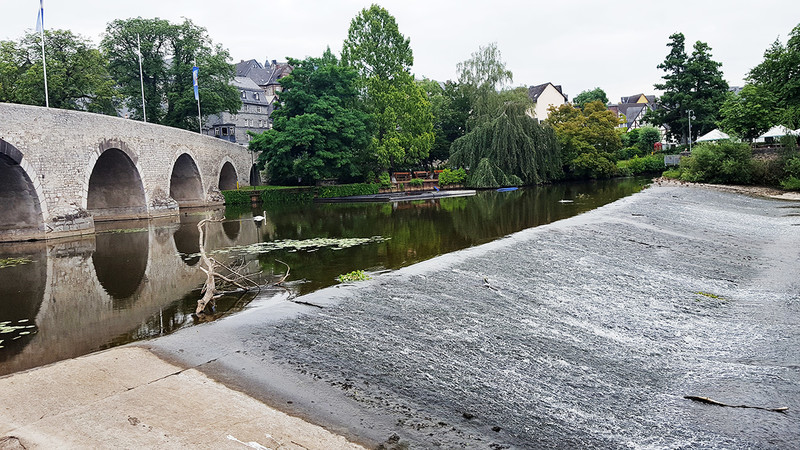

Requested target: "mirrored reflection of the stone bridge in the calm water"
[{"left": 0, "top": 214, "right": 258, "bottom": 375}]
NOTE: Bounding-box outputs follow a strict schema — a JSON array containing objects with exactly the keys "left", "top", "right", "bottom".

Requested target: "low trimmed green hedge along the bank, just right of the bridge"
[{"left": 222, "top": 183, "right": 380, "bottom": 205}]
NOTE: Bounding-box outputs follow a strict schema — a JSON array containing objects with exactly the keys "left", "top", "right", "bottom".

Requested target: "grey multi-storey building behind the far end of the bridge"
[{"left": 204, "top": 76, "right": 272, "bottom": 145}]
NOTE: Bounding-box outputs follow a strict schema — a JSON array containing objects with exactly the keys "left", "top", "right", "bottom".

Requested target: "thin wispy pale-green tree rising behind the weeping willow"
[{"left": 456, "top": 42, "right": 514, "bottom": 129}]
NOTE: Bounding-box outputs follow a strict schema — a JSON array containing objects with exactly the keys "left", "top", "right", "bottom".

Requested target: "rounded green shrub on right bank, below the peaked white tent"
[{"left": 681, "top": 141, "right": 753, "bottom": 184}]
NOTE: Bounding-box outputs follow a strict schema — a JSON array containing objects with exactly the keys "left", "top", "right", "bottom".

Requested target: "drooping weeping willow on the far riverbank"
[{"left": 450, "top": 102, "right": 563, "bottom": 188}]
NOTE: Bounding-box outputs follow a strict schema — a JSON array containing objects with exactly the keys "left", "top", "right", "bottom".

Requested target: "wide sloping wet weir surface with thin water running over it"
[{"left": 143, "top": 187, "right": 800, "bottom": 448}]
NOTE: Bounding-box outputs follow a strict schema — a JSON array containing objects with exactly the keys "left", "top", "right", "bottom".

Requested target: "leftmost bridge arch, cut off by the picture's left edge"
[{"left": 0, "top": 139, "right": 47, "bottom": 241}]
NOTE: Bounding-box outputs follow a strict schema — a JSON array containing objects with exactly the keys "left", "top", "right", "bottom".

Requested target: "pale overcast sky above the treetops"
[{"left": 0, "top": 0, "right": 800, "bottom": 102}]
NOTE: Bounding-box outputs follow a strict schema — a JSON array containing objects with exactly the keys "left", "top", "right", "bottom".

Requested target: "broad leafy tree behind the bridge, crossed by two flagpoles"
[{"left": 100, "top": 17, "right": 241, "bottom": 130}]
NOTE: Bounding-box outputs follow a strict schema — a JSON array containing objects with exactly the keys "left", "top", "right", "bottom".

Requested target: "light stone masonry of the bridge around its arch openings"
[{"left": 0, "top": 103, "right": 252, "bottom": 238}]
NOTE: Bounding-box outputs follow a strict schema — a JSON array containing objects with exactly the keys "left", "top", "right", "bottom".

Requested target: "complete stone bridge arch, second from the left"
[{"left": 83, "top": 140, "right": 149, "bottom": 221}]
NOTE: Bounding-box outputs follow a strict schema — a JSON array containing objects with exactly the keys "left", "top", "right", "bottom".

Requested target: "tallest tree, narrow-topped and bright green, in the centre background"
[{"left": 342, "top": 5, "right": 434, "bottom": 169}]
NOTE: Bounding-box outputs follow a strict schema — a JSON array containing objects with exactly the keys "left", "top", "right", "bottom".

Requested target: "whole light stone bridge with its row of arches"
[{"left": 0, "top": 103, "right": 258, "bottom": 242}]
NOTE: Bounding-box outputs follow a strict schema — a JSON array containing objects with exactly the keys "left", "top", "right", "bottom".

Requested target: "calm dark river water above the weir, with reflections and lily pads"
[{"left": 0, "top": 179, "right": 646, "bottom": 375}]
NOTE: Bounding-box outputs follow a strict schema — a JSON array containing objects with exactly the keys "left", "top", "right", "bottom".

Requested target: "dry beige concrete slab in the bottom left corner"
[{"left": 0, "top": 347, "right": 362, "bottom": 449}]
